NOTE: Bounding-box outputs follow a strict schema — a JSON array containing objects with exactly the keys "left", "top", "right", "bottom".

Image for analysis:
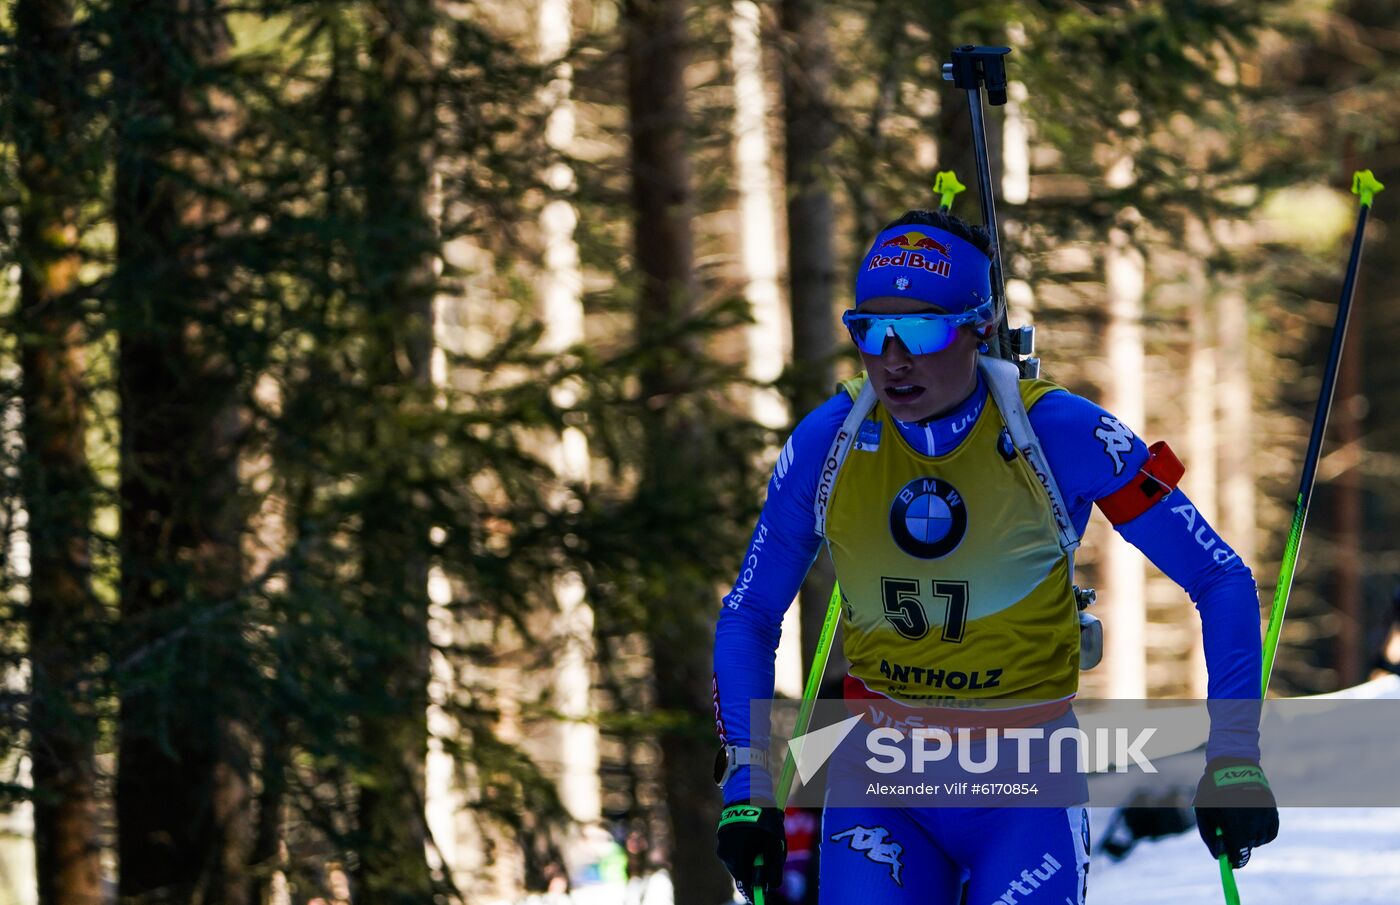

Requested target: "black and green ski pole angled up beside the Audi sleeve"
[{"left": 1260, "top": 170, "right": 1386, "bottom": 698}]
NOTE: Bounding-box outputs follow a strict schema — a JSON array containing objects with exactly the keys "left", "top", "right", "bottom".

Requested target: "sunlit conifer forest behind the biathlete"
[{"left": 0, "top": 0, "right": 1400, "bottom": 905}]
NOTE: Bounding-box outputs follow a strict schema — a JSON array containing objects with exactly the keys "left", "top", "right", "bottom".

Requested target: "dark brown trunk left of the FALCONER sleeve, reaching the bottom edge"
[{"left": 622, "top": 0, "right": 732, "bottom": 905}]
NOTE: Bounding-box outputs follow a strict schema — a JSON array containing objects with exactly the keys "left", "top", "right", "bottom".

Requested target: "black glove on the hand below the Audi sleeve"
[{"left": 1196, "top": 758, "right": 1278, "bottom": 867}]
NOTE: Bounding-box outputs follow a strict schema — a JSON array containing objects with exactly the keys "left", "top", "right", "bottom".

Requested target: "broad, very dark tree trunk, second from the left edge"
[{"left": 113, "top": 0, "right": 251, "bottom": 904}]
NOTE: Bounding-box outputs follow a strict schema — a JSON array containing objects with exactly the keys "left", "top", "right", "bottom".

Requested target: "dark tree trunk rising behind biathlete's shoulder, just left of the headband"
[{"left": 780, "top": 0, "right": 836, "bottom": 689}]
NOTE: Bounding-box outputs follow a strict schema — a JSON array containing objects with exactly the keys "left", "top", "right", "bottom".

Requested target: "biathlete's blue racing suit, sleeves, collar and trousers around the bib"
[{"left": 714, "top": 374, "right": 1261, "bottom": 905}]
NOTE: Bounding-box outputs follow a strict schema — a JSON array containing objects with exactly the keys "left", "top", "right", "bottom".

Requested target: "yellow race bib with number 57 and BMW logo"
[{"left": 826, "top": 374, "right": 1079, "bottom": 703}]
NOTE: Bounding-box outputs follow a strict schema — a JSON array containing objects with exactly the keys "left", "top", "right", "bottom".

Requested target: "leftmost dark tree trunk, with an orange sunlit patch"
[{"left": 14, "top": 0, "right": 104, "bottom": 905}]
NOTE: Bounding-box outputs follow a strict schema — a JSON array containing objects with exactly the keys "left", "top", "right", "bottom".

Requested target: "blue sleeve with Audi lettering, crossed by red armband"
[{"left": 1030, "top": 391, "right": 1263, "bottom": 759}]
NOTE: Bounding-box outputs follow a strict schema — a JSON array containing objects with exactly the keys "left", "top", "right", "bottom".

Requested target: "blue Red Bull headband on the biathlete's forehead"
[{"left": 855, "top": 224, "right": 991, "bottom": 314}]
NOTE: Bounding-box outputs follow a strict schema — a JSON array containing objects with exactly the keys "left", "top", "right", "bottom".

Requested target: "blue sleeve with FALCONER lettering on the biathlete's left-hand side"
[{"left": 714, "top": 392, "right": 851, "bottom": 804}]
